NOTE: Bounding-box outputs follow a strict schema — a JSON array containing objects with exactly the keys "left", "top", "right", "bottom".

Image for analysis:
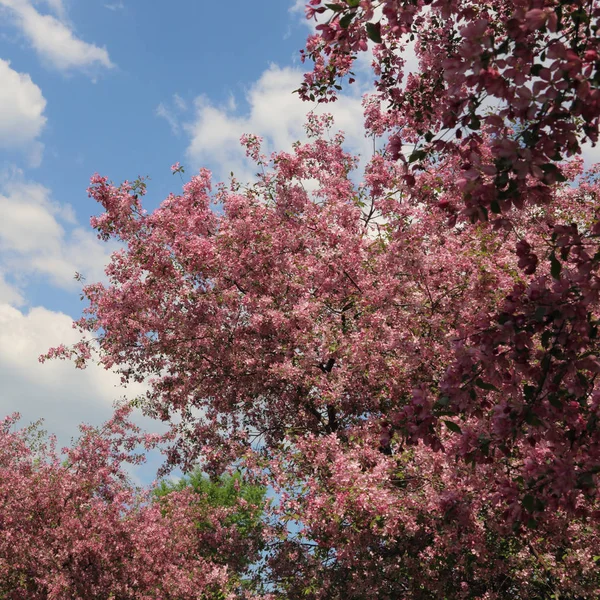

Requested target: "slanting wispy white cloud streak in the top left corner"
[{"left": 0, "top": 0, "right": 114, "bottom": 72}]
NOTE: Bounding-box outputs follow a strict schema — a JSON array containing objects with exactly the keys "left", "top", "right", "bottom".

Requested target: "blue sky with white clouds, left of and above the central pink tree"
[{"left": 0, "top": 0, "right": 369, "bottom": 468}]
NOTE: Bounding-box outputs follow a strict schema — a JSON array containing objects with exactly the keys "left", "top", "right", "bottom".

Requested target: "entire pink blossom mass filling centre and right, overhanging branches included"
[{"left": 34, "top": 0, "right": 600, "bottom": 600}]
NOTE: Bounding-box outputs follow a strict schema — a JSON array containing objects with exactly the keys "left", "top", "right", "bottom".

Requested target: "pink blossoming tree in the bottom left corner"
[{"left": 0, "top": 409, "right": 264, "bottom": 600}]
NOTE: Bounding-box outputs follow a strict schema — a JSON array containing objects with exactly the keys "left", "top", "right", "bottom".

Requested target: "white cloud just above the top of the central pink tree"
[{"left": 184, "top": 65, "right": 372, "bottom": 181}]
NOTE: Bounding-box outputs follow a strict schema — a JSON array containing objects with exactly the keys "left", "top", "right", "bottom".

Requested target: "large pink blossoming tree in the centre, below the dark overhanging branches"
[{"left": 44, "top": 117, "right": 600, "bottom": 600}]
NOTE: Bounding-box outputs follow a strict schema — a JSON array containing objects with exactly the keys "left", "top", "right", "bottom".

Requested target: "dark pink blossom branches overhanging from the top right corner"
[{"left": 299, "top": 0, "right": 600, "bottom": 219}]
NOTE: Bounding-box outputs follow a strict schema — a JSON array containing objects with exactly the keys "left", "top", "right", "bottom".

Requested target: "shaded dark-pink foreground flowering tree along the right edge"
[{"left": 300, "top": 0, "right": 600, "bottom": 508}]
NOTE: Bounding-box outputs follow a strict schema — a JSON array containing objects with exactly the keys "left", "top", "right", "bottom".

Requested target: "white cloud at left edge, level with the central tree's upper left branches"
[{"left": 0, "top": 175, "right": 111, "bottom": 289}]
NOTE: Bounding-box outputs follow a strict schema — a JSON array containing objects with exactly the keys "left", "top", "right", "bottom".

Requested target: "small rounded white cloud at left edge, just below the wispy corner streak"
[{"left": 0, "top": 59, "right": 47, "bottom": 166}]
